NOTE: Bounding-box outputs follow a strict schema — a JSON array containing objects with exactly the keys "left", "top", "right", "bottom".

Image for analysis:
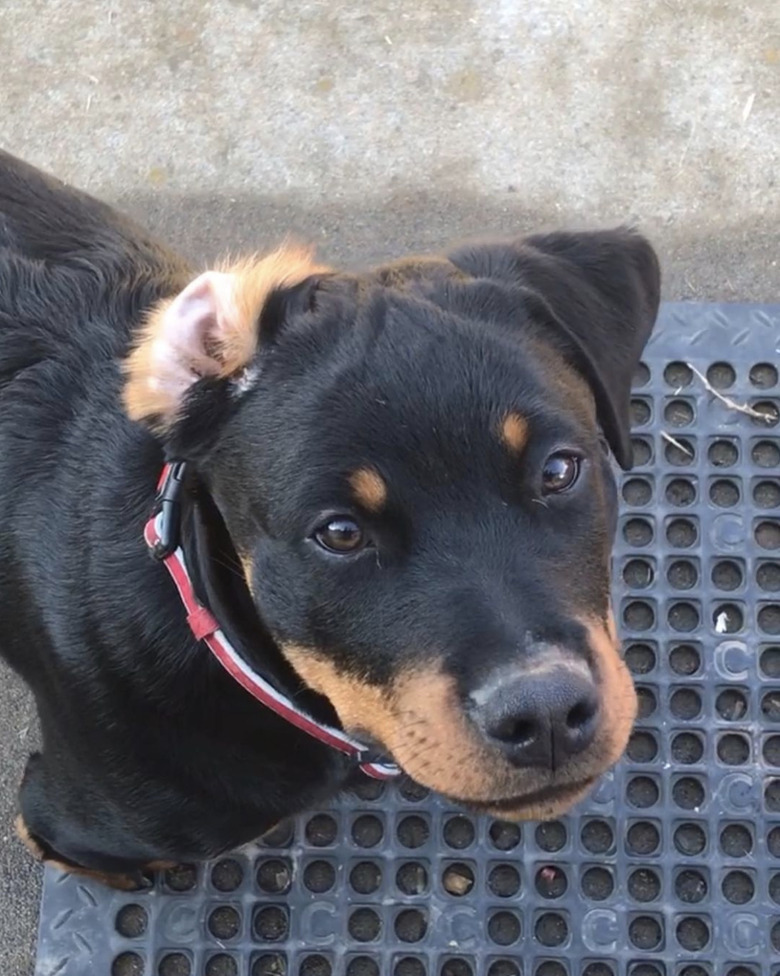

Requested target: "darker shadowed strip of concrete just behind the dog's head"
[{"left": 117, "top": 190, "right": 780, "bottom": 301}]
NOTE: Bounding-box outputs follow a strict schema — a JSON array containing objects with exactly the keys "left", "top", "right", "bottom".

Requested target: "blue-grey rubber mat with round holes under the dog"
[{"left": 37, "top": 304, "right": 780, "bottom": 976}]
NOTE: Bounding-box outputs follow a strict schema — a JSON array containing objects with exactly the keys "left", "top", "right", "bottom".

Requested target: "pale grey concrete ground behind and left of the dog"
[{"left": 0, "top": 0, "right": 780, "bottom": 976}]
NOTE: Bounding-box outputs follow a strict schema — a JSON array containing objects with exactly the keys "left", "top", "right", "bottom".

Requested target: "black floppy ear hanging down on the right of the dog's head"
[{"left": 450, "top": 228, "right": 660, "bottom": 469}]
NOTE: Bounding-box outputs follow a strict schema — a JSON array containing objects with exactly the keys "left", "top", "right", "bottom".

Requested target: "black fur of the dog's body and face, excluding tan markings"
[{"left": 0, "top": 155, "right": 658, "bottom": 871}]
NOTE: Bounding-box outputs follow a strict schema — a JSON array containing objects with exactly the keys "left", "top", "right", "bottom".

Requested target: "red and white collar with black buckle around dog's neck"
[{"left": 144, "top": 462, "right": 400, "bottom": 780}]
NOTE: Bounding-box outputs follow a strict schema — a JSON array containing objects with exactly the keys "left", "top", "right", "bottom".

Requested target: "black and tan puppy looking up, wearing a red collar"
[{"left": 0, "top": 156, "right": 659, "bottom": 886}]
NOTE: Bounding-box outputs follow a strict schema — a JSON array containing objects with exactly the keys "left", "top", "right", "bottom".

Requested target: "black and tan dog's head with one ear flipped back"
[{"left": 124, "top": 230, "right": 659, "bottom": 817}]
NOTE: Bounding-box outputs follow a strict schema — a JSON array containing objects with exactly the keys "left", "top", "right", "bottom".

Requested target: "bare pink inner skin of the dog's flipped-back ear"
[{"left": 150, "top": 271, "right": 237, "bottom": 401}]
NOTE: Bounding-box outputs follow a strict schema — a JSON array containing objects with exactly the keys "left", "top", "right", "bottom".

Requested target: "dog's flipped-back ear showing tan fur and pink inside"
[{"left": 123, "top": 247, "right": 325, "bottom": 434}]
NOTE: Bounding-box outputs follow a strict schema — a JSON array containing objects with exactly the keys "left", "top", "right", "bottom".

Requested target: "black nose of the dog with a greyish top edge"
[{"left": 472, "top": 665, "right": 599, "bottom": 769}]
